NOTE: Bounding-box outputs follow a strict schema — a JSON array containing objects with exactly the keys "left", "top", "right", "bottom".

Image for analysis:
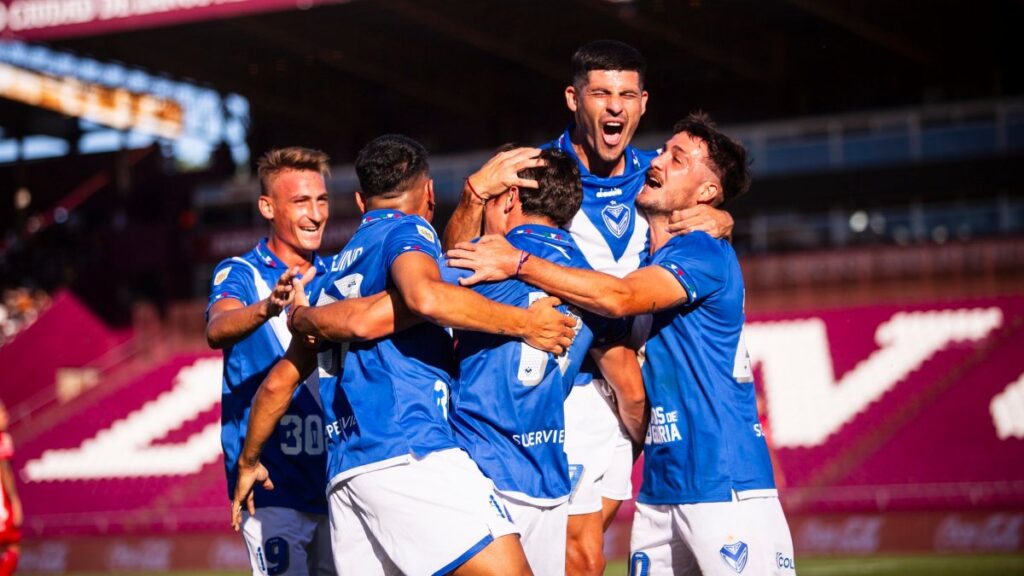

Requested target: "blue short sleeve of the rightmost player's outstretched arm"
[{"left": 654, "top": 232, "right": 726, "bottom": 304}]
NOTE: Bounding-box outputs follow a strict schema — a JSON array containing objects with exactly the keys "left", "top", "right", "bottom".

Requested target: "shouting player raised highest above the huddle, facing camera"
[{"left": 444, "top": 40, "right": 732, "bottom": 576}]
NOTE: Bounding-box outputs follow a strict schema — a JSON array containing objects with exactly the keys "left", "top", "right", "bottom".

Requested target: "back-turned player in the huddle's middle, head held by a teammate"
[{"left": 443, "top": 149, "right": 645, "bottom": 574}]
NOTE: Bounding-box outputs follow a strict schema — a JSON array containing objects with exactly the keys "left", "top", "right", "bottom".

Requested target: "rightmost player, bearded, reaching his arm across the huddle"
[{"left": 449, "top": 115, "right": 795, "bottom": 576}]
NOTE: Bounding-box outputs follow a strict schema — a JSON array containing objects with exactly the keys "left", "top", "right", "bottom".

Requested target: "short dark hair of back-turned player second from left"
[{"left": 355, "top": 134, "right": 430, "bottom": 198}]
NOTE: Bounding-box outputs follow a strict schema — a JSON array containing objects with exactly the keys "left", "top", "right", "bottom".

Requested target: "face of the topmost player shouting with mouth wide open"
[{"left": 565, "top": 70, "right": 647, "bottom": 163}]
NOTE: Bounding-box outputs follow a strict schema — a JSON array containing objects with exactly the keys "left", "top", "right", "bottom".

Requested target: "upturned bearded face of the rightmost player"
[{"left": 637, "top": 132, "right": 718, "bottom": 214}]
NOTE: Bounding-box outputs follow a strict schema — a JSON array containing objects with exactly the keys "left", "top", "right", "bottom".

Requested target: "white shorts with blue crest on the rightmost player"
[{"left": 630, "top": 497, "right": 797, "bottom": 576}]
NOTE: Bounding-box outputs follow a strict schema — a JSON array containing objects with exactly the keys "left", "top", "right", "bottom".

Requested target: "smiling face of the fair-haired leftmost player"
[{"left": 264, "top": 170, "right": 328, "bottom": 252}]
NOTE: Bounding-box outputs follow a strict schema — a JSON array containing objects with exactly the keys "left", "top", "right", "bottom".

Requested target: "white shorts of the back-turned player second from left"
[{"left": 328, "top": 449, "right": 519, "bottom": 576}]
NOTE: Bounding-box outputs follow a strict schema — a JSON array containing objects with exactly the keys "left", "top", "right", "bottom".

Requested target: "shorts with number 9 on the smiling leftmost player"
[{"left": 242, "top": 506, "right": 335, "bottom": 576}]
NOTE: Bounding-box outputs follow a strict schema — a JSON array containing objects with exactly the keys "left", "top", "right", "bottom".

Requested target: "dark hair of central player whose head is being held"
[{"left": 519, "top": 149, "right": 583, "bottom": 228}]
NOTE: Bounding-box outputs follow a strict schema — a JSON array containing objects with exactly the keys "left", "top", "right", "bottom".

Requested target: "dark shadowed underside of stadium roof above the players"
[{"left": 0, "top": 0, "right": 1024, "bottom": 162}]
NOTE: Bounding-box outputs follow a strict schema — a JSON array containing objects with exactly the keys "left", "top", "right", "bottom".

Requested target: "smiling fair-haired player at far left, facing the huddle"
[{"left": 207, "top": 148, "right": 334, "bottom": 575}]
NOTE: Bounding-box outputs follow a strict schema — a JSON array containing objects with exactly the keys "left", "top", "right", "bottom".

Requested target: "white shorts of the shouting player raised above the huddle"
[{"left": 565, "top": 379, "right": 633, "bottom": 516}]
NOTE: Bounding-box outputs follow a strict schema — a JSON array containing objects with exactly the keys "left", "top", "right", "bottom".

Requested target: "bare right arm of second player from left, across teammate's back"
[{"left": 391, "top": 251, "right": 575, "bottom": 354}]
